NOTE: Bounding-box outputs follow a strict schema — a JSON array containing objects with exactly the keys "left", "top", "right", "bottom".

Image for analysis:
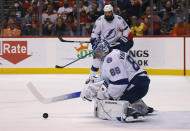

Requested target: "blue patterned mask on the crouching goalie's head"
[{"left": 93, "top": 40, "right": 110, "bottom": 59}]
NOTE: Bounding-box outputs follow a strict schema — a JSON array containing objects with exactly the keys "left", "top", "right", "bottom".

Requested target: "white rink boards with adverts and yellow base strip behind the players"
[{"left": 0, "top": 37, "right": 190, "bottom": 75}]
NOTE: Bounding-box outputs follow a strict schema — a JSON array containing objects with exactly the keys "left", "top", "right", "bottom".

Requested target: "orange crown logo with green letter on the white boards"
[{"left": 74, "top": 43, "right": 92, "bottom": 58}]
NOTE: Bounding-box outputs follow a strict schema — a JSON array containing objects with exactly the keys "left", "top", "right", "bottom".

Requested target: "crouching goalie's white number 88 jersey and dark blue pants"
[{"left": 100, "top": 49, "right": 150, "bottom": 103}]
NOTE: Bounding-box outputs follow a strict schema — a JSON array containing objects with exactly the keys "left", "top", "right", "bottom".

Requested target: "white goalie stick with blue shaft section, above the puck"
[{"left": 27, "top": 82, "right": 81, "bottom": 104}]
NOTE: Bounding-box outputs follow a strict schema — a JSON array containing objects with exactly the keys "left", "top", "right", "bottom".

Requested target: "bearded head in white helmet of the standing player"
[{"left": 104, "top": 5, "right": 114, "bottom": 22}]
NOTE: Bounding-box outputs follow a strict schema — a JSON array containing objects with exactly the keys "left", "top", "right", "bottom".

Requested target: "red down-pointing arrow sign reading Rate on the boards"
[{"left": 0, "top": 41, "right": 31, "bottom": 64}]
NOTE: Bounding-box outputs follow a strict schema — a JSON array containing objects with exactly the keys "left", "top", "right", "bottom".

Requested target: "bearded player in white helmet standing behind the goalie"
[{"left": 87, "top": 4, "right": 133, "bottom": 81}]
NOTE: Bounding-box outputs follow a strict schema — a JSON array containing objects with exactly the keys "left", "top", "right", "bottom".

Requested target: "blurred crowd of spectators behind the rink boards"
[{"left": 0, "top": 0, "right": 190, "bottom": 37}]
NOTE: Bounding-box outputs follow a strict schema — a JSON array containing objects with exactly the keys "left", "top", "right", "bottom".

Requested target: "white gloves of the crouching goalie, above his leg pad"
[{"left": 81, "top": 81, "right": 109, "bottom": 101}]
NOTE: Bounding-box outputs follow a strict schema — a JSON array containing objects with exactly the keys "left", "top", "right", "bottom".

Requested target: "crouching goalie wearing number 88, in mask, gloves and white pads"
[{"left": 81, "top": 41, "right": 150, "bottom": 122}]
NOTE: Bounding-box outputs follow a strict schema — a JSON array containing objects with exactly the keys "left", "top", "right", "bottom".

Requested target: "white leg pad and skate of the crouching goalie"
[{"left": 94, "top": 100, "right": 144, "bottom": 122}]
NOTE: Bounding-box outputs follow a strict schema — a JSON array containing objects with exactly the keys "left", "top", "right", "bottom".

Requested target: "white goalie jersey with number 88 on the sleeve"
[{"left": 101, "top": 49, "right": 146, "bottom": 99}]
